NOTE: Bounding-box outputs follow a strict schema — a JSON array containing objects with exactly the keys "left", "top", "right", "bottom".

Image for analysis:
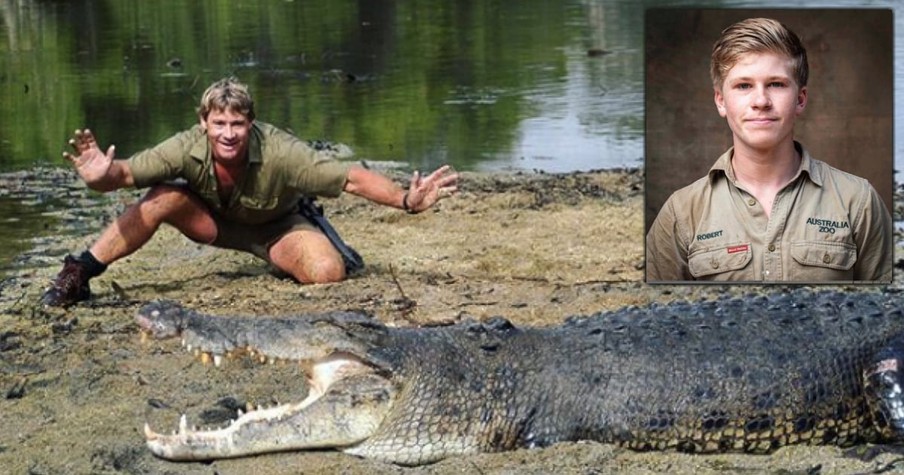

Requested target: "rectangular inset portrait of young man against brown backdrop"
[{"left": 645, "top": 8, "right": 894, "bottom": 283}]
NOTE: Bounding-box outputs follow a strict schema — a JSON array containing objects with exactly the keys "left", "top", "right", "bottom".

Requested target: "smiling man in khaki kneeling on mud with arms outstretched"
[{"left": 42, "top": 78, "right": 458, "bottom": 306}]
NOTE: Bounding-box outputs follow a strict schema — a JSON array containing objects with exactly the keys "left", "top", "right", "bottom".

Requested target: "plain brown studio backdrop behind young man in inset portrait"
[{"left": 644, "top": 9, "right": 894, "bottom": 235}]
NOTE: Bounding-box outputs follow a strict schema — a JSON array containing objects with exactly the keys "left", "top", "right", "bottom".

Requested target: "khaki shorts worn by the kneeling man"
[{"left": 210, "top": 213, "right": 321, "bottom": 264}]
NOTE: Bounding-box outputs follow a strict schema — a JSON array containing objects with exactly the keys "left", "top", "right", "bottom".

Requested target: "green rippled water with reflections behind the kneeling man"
[{"left": 0, "top": 0, "right": 642, "bottom": 175}]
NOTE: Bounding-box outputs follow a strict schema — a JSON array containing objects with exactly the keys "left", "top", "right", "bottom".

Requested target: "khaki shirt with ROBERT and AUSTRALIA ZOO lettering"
[{"left": 646, "top": 142, "right": 893, "bottom": 282}]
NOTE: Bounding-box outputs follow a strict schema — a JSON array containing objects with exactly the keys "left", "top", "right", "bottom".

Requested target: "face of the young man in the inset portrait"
[{"left": 715, "top": 53, "right": 807, "bottom": 152}]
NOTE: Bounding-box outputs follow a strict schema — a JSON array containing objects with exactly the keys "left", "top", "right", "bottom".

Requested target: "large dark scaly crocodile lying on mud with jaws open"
[{"left": 136, "top": 290, "right": 904, "bottom": 465}]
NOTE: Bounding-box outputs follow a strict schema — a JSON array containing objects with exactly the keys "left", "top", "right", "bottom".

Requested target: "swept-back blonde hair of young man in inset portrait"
[{"left": 709, "top": 18, "right": 810, "bottom": 88}]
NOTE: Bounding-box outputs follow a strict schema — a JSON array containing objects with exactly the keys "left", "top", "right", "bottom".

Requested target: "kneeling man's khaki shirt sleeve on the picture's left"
[{"left": 127, "top": 130, "right": 195, "bottom": 188}]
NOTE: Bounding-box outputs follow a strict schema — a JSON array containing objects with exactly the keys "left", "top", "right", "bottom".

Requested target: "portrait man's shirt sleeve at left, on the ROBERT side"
[{"left": 646, "top": 197, "right": 693, "bottom": 282}]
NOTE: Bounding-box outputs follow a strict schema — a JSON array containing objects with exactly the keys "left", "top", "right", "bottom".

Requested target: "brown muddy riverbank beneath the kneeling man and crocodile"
[{"left": 0, "top": 166, "right": 901, "bottom": 474}]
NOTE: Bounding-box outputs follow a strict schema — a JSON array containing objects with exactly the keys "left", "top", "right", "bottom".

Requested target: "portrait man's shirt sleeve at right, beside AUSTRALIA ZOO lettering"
[{"left": 854, "top": 183, "right": 894, "bottom": 283}]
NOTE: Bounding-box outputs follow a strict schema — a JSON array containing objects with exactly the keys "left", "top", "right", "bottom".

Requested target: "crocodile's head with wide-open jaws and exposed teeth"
[{"left": 135, "top": 301, "right": 398, "bottom": 460}]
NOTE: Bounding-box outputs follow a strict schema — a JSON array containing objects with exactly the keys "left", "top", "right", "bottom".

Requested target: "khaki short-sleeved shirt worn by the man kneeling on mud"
[{"left": 128, "top": 121, "right": 349, "bottom": 224}]
